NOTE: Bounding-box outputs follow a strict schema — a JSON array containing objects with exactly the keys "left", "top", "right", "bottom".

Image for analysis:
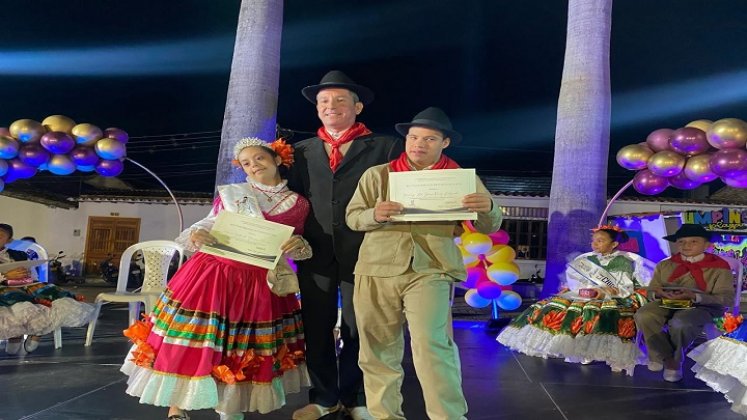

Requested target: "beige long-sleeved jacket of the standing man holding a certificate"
[{"left": 345, "top": 164, "right": 503, "bottom": 280}]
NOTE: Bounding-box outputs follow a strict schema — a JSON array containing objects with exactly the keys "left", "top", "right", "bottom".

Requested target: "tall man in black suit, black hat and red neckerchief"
[{"left": 288, "top": 70, "right": 402, "bottom": 420}]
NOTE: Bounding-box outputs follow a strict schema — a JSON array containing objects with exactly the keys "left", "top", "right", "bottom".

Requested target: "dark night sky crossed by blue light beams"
[{"left": 0, "top": 0, "right": 747, "bottom": 191}]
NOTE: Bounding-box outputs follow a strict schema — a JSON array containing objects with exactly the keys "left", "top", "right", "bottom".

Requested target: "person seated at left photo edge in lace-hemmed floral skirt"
[{"left": 0, "top": 223, "right": 94, "bottom": 354}]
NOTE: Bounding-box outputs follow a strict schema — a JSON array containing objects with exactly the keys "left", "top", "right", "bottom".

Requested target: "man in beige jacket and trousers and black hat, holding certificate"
[{"left": 346, "top": 107, "right": 502, "bottom": 420}]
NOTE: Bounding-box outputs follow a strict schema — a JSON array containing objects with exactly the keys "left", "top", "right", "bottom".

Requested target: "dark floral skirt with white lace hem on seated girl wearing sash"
[{"left": 497, "top": 292, "right": 646, "bottom": 375}]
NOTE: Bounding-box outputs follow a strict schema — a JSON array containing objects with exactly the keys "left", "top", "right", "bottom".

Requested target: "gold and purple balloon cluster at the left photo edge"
[{"left": 0, "top": 115, "right": 129, "bottom": 191}]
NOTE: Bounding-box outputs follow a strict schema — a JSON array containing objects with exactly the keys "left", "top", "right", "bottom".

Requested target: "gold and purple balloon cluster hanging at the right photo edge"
[{"left": 617, "top": 118, "right": 747, "bottom": 195}]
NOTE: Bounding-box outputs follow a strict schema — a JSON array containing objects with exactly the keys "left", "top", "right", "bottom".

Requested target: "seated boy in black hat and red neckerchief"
[{"left": 635, "top": 224, "right": 734, "bottom": 382}]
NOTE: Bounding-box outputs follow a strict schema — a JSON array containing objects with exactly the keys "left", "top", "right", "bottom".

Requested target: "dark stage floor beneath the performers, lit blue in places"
[{"left": 0, "top": 305, "right": 742, "bottom": 420}]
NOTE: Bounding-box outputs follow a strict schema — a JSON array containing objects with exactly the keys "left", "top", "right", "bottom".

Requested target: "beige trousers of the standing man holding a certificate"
[{"left": 353, "top": 270, "right": 467, "bottom": 420}]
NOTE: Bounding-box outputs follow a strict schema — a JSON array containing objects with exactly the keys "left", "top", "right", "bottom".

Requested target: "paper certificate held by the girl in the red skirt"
[{"left": 200, "top": 211, "right": 293, "bottom": 270}]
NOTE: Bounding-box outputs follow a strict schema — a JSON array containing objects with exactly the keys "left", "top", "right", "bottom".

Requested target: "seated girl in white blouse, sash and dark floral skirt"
[{"left": 498, "top": 226, "right": 652, "bottom": 375}]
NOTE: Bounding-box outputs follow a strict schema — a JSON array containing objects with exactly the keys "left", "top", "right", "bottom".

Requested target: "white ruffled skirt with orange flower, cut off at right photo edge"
[{"left": 688, "top": 314, "right": 747, "bottom": 416}]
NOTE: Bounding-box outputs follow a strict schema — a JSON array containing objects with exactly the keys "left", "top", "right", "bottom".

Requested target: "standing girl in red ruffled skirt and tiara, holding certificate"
[{"left": 122, "top": 138, "right": 311, "bottom": 420}]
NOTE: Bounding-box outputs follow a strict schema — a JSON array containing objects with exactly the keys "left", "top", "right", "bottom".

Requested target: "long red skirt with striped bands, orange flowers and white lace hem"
[{"left": 121, "top": 253, "right": 309, "bottom": 414}]
